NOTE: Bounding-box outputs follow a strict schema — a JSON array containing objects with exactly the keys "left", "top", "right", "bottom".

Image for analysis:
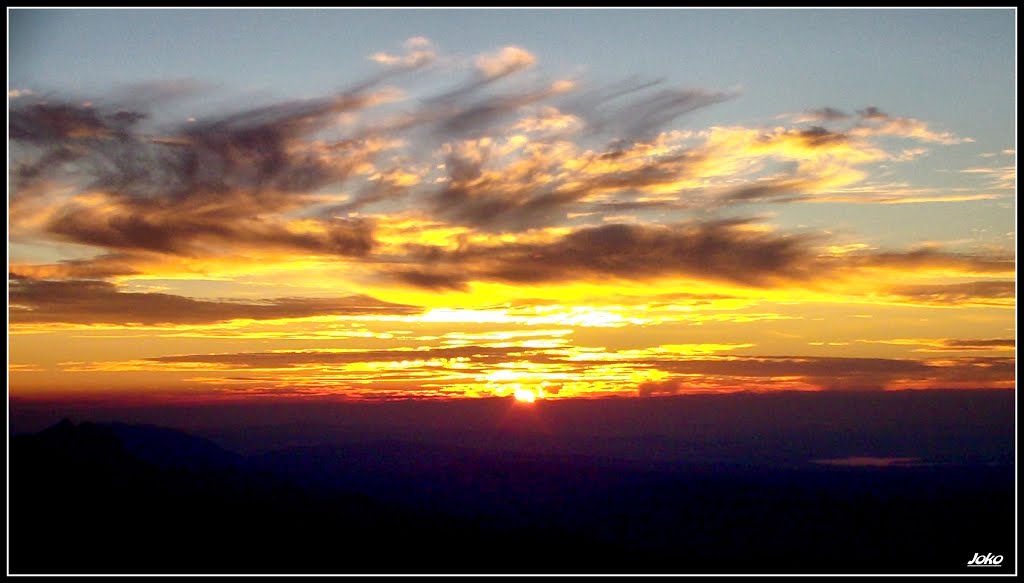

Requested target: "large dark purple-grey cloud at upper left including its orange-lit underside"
[{"left": 9, "top": 88, "right": 389, "bottom": 255}]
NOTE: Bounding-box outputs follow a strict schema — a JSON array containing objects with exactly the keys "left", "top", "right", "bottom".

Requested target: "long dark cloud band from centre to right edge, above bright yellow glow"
[{"left": 381, "top": 218, "right": 1015, "bottom": 293}]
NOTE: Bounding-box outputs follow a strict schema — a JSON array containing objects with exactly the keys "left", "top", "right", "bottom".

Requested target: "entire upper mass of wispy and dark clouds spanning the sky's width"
[{"left": 9, "top": 45, "right": 999, "bottom": 299}]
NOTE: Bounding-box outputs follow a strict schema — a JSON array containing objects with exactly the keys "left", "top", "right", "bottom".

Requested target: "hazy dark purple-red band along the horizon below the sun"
[{"left": 8, "top": 389, "right": 1016, "bottom": 459}]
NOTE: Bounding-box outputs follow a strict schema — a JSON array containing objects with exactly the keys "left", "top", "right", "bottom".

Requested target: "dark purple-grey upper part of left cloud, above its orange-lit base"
[{"left": 9, "top": 93, "right": 373, "bottom": 200}]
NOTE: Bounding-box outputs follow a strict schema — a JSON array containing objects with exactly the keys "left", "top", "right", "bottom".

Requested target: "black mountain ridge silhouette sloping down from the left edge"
[{"left": 9, "top": 420, "right": 616, "bottom": 574}]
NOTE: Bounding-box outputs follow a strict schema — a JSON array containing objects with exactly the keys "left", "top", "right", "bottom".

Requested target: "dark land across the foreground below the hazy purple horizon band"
[{"left": 9, "top": 394, "right": 1016, "bottom": 574}]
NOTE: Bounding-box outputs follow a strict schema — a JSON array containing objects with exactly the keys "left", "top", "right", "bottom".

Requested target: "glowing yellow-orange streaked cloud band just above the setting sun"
[{"left": 83, "top": 344, "right": 1016, "bottom": 397}]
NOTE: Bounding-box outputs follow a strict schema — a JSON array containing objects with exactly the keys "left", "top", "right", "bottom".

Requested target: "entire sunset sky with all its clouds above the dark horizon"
[{"left": 7, "top": 8, "right": 1017, "bottom": 403}]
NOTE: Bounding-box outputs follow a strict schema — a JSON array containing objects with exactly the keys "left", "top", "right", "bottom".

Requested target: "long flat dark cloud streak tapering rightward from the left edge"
[{"left": 8, "top": 275, "right": 422, "bottom": 325}]
